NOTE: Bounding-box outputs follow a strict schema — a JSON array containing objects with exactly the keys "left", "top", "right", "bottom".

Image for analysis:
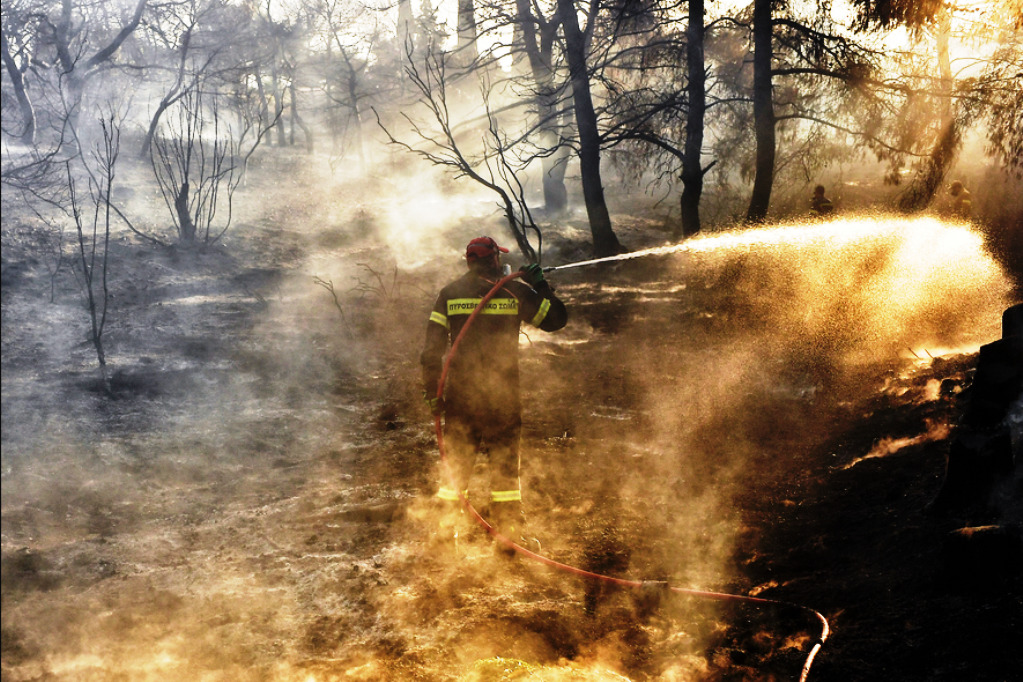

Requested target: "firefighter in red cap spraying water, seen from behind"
[{"left": 420, "top": 236, "right": 568, "bottom": 552}]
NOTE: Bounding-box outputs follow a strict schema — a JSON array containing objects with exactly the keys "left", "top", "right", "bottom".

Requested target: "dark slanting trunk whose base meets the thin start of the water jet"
[{"left": 558, "top": 0, "right": 622, "bottom": 258}]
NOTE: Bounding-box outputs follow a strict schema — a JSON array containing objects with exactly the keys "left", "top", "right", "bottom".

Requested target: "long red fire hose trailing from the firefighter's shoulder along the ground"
[{"left": 434, "top": 268, "right": 831, "bottom": 682}]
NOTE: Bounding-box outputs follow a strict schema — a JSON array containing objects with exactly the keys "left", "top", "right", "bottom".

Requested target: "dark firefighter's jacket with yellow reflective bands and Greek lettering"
[{"left": 420, "top": 270, "right": 568, "bottom": 418}]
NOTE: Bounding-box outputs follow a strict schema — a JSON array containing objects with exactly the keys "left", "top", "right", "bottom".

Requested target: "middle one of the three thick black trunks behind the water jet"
[{"left": 679, "top": 0, "right": 707, "bottom": 237}]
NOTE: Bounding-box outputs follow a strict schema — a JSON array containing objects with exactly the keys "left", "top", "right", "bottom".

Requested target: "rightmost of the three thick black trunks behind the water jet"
[{"left": 746, "top": 0, "right": 776, "bottom": 223}]
